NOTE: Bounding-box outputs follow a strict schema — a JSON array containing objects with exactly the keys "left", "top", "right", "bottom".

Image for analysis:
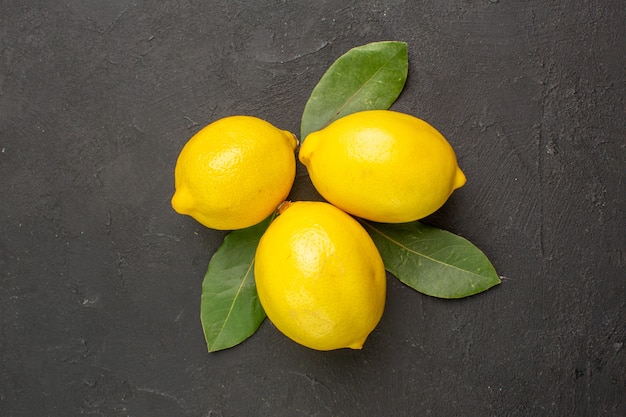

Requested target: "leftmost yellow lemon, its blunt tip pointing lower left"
[{"left": 172, "top": 116, "right": 297, "bottom": 230}]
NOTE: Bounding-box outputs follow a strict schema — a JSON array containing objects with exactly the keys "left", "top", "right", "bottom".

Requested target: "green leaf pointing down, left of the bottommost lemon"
[{"left": 200, "top": 217, "right": 271, "bottom": 352}]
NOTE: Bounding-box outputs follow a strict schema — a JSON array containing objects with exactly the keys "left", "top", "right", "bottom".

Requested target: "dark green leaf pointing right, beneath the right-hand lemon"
[{"left": 363, "top": 222, "right": 500, "bottom": 298}]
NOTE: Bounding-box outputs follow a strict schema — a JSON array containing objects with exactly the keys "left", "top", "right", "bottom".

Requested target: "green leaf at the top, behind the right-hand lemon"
[{"left": 300, "top": 41, "right": 409, "bottom": 141}]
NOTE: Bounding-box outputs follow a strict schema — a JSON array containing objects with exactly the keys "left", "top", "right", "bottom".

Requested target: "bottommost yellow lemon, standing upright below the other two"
[{"left": 254, "top": 201, "right": 386, "bottom": 350}]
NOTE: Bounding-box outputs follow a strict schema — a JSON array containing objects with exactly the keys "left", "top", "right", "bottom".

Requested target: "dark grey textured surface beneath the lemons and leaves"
[{"left": 0, "top": 0, "right": 626, "bottom": 417}]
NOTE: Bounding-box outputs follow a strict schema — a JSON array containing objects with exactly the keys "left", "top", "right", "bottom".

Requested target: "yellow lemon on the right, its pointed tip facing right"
[{"left": 299, "top": 110, "right": 465, "bottom": 223}]
